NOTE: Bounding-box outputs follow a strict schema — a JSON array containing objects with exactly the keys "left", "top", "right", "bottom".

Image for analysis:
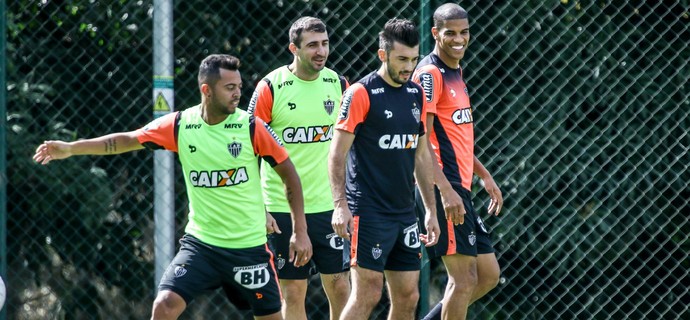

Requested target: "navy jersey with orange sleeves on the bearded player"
[{"left": 336, "top": 72, "right": 426, "bottom": 214}]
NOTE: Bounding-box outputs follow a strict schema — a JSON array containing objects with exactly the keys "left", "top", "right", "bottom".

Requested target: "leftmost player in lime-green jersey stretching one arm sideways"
[{"left": 33, "top": 55, "right": 312, "bottom": 319}]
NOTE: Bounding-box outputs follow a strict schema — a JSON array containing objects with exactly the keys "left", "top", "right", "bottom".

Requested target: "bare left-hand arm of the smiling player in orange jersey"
[{"left": 426, "top": 113, "right": 465, "bottom": 225}]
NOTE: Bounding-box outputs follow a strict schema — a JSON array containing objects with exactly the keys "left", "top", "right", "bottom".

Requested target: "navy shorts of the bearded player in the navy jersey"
[{"left": 350, "top": 212, "right": 422, "bottom": 272}]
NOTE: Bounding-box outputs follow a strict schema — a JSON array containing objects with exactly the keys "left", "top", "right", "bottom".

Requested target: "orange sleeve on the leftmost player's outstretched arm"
[{"left": 136, "top": 111, "right": 179, "bottom": 152}]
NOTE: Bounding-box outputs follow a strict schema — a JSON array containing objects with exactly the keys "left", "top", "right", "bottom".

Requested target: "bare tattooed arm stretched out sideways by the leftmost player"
[{"left": 33, "top": 131, "right": 144, "bottom": 165}]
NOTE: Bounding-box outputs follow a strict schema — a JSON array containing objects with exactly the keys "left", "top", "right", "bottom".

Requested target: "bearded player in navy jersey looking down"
[{"left": 328, "top": 19, "right": 439, "bottom": 320}]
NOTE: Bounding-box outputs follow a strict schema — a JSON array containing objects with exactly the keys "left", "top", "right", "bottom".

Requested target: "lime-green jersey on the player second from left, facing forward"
[{"left": 247, "top": 66, "right": 347, "bottom": 214}]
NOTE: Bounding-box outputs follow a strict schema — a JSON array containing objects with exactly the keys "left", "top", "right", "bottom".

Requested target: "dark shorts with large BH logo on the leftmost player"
[{"left": 158, "top": 234, "right": 282, "bottom": 316}]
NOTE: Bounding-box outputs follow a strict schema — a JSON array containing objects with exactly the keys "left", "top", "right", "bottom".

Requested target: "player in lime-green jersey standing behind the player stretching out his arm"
[{"left": 248, "top": 17, "right": 350, "bottom": 320}]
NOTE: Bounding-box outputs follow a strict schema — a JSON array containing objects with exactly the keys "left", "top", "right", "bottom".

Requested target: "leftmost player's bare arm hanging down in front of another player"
[{"left": 273, "top": 158, "right": 312, "bottom": 267}]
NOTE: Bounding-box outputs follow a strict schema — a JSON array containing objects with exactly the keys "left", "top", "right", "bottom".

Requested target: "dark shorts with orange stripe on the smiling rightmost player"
[{"left": 415, "top": 186, "right": 494, "bottom": 258}]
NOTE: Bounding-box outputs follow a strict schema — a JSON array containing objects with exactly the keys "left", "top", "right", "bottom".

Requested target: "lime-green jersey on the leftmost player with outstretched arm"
[{"left": 136, "top": 105, "right": 287, "bottom": 249}]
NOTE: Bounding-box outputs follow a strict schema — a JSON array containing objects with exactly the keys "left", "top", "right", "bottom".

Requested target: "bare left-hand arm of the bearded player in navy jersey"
[{"left": 328, "top": 130, "right": 355, "bottom": 240}]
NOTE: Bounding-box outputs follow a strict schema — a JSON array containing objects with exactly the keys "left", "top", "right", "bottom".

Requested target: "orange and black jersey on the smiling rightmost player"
[{"left": 412, "top": 53, "right": 474, "bottom": 190}]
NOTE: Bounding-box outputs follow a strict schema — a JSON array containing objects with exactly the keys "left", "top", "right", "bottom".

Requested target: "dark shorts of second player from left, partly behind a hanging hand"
[{"left": 269, "top": 210, "right": 350, "bottom": 280}]
